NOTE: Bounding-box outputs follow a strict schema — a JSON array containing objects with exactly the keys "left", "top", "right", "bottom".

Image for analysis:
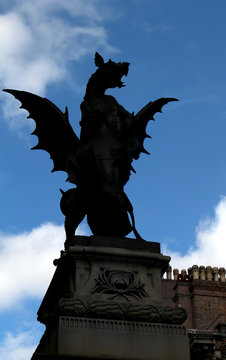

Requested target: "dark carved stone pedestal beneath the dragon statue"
[{"left": 32, "top": 236, "right": 189, "bottom": 360}]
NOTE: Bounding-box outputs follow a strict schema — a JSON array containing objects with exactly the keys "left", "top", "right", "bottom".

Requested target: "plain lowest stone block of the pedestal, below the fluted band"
[{"left": 32, "top": 316, "right": 190, "bottom": 360}]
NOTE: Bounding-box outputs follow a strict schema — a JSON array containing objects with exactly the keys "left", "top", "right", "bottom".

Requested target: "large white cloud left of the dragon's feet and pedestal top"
[{"left": 0, "top": 223, "right": 87, "bottom": 311}]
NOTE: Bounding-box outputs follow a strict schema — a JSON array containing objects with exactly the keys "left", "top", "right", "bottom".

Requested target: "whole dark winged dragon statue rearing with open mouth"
[{"left": 4, "top": 53, "right": 177, "bottom": 242}]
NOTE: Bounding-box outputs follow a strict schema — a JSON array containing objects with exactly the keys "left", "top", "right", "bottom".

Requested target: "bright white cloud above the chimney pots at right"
[{"left": 163, "top": 197, "right": 226, "bottom": 270}]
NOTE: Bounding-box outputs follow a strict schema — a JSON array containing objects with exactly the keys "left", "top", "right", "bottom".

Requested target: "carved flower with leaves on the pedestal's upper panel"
[{"left": 92, "top": 268, "right": 147, "bottom": 301}]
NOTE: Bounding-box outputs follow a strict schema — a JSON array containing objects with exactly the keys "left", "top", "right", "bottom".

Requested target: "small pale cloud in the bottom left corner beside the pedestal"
[{"left": 0, "top": 326, "right": 41, "bottom": 360}]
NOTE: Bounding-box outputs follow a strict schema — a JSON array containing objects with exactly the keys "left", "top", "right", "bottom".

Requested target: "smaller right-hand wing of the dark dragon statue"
[{"left": 134, "top": 98, "right": 178, "bottom": 154}]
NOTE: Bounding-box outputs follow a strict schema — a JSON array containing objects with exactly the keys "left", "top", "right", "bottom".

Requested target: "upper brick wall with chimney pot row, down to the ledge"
[{"left": 162, "top": 265, "right": 226, "bottom": 331}]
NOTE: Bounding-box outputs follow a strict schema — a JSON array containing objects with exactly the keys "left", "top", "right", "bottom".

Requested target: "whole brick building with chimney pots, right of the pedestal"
[{"left": 162, "top": 265, "right": 226, "bottom": 360}]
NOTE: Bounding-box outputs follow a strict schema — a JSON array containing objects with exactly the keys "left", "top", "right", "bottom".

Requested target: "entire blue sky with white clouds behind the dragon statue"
[{"left": 0, "top": 0, "right": 226, "bottom": 360}]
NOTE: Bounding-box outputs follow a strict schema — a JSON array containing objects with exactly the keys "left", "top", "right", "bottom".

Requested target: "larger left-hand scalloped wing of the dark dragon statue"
[{"left": 3, "top": 89, "right": 79, "bottom": 181}]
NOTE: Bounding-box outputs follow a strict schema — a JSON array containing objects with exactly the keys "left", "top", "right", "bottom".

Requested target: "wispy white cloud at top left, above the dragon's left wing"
[{"left": 0, "top": 0, "right": 114, "bottom": 128}]
